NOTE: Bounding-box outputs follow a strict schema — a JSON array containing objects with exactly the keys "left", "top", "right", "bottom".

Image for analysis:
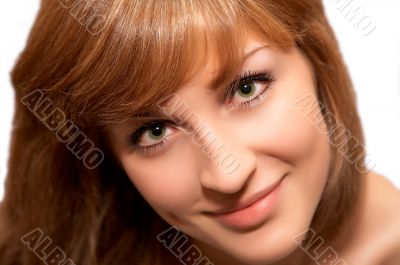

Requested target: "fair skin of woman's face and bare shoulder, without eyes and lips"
[{"left": 109, "top": 34, "right": 400, "bottom": 265}]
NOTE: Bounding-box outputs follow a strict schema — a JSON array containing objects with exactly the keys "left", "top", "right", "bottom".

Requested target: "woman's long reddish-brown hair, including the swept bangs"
[{"left": 0, "top": 0, "right": 363, "bottom": 265}]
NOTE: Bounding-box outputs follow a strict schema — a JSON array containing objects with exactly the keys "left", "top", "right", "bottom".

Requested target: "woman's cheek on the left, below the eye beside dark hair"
[{"left": 118, "top": 140, "right": 200, "bottom": 212}]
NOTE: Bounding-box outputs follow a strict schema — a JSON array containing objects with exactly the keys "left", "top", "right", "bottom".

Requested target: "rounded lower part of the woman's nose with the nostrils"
[{"left": 200, "top": 135, "right": 257, "bottom": 194}]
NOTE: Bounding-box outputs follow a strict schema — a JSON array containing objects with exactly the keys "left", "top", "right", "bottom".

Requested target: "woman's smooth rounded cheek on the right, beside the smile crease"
[{"left": 246, "top": 91, "right": 329, "bottom": 165}]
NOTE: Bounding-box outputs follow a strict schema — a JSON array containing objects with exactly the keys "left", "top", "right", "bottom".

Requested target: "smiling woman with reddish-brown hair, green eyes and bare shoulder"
[{"left": 0, "top": 0, "right": 400, "bottom": 265}]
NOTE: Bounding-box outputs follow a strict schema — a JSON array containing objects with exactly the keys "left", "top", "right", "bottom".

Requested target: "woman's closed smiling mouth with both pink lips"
[{"left": 206, "top": 175, "right": 286, "bottom": 230}]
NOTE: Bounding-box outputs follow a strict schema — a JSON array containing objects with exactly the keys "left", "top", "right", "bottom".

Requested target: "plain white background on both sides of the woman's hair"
[{"left": 0, "top": 0, "right": 400, "bottom": 199}]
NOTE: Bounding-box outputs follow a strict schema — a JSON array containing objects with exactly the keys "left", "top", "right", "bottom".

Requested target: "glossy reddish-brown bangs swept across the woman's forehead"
[{"left": 55, "top": 0, "right": 293, "bottom": 126}]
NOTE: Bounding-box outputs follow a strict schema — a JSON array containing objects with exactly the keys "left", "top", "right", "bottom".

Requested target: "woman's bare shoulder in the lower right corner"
[{"left": 331, "top": 173, "right": 400, "bottom": 265}]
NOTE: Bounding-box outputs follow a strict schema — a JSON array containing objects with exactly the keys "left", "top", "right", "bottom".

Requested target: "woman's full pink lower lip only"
[{"left": 214, "top": 181, "right": 282, "bottom": 229}]
